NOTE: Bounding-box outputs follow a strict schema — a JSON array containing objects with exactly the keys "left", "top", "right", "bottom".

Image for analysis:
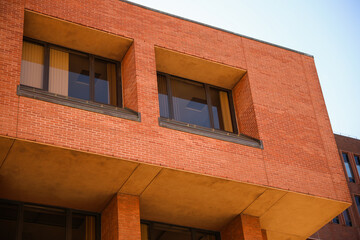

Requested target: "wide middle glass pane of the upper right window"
[{"left": 171, "top": 78, "right": 211, "bottom": 127}]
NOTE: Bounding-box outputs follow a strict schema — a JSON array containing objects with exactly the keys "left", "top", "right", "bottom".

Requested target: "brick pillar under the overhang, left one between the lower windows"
[{"left": 101, "top": 194, "right": 141, "bottom": 240}]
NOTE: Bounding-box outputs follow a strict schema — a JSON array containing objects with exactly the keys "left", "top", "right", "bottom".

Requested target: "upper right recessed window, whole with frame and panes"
[{"left": 158, "top": 73, "right": 237, "bottom": 133}]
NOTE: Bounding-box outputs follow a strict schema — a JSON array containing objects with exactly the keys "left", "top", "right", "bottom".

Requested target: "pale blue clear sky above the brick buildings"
[{"left": 131, "top": 0, "right": 360, "bottom": 139}]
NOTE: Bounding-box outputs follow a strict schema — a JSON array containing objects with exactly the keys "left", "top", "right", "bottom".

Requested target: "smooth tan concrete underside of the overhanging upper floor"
[{"left": 0, "top": 137, "right": 350, "bottom": 240}]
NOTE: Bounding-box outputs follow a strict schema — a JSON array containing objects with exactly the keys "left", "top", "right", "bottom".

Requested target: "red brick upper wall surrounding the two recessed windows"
[{"left": 0, "top": 0, "right": 349, "bottom": 201}]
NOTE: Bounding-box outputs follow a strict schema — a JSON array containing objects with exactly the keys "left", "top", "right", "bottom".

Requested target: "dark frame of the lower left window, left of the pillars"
[{"left": 0, "top": 199, "right": 101, "bottom": 240}]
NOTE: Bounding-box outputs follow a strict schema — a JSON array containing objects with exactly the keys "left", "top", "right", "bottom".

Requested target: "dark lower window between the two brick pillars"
[{"left": 141, "top": 220, "right": 220, "bottom": 240}]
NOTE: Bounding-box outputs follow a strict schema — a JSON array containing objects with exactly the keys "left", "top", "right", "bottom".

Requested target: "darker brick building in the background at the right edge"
[{"left": 312, "top": 134, "right": 360, "bottom": 240}]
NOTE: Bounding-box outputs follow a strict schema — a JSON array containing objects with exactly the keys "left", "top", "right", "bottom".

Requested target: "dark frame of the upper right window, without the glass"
[{"left": 156, "top": 71, "right": 238, "bottom": 134}]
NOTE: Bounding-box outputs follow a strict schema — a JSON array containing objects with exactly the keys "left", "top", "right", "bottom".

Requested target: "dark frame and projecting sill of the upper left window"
[{"left": 17, "top": 36, "right": 141, "bottom": 122}]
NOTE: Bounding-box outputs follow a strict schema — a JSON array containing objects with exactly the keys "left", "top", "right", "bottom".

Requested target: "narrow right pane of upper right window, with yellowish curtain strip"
[{"left": 210, "top": 88, "right": 233, "bottom": 132}]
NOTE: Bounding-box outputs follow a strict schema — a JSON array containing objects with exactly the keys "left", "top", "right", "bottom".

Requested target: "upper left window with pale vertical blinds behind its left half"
[{"left": 20, "top": 39, "right": 122, "bottom": 107}]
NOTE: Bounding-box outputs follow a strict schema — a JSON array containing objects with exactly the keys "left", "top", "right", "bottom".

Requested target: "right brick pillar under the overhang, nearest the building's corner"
[{"left": 221, "top": 215, "right": 267, "bottom": 240}]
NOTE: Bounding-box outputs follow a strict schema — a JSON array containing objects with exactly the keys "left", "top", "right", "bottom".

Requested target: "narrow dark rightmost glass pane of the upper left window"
[{"left": 94, "top": 59, "right": 110, "bottom": 104}]
